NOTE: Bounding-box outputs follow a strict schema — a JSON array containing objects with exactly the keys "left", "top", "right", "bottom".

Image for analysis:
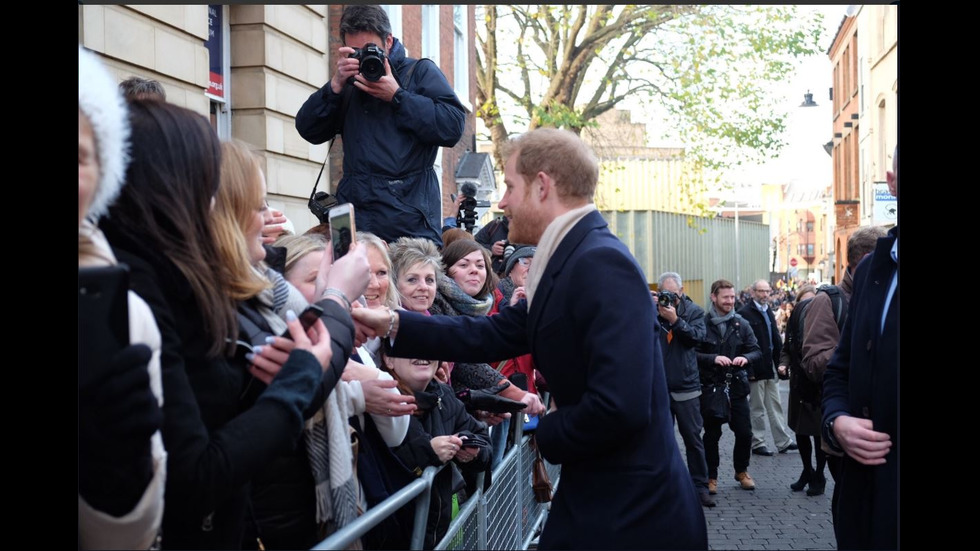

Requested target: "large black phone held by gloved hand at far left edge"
[{"left": 78, "top": 264, "right": 129, "bottom": 386}]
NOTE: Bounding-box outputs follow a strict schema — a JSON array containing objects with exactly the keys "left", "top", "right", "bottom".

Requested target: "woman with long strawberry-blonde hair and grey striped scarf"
[{"left": 213, "top": 141, "right": 380, "bottom": 548}]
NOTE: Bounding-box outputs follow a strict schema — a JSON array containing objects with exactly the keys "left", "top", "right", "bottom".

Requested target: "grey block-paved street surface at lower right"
[{"left": 677, "top": 381, "right": 836, "bottom": 549}]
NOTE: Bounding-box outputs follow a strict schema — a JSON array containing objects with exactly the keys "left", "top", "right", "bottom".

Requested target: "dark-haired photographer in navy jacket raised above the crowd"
[{"left": 296, "top": 5, "right": 465, "bottom": 246}]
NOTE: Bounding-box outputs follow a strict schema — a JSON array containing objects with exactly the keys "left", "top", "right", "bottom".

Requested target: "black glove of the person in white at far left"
[{"left": 78, "top": 344, "right": 163, "bottom": 516}]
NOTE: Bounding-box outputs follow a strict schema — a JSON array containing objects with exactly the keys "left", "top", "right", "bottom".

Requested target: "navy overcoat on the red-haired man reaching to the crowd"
[{"left": 394, "top": 212, "right": 708, "bottom": 549}]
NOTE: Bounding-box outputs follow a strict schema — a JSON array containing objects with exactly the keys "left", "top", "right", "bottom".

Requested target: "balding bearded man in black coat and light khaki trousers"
[{"left": 738, "top": 279, "right": 797, "bottom": 455}]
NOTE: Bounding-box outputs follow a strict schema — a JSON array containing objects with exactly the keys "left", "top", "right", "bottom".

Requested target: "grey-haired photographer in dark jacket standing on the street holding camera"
[{"left": 656, "top": 272, "right": 715, "bottom": 507}]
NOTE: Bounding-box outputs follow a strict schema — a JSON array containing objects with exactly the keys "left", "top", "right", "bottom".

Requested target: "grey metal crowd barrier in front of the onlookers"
[{"left": 313, "top": 416, "right": 561, "bottom": 550}]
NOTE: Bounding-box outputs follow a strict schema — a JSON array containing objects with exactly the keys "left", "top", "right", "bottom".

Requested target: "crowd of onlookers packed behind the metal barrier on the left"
[{"left": 78, "top": 36, "right": 544, "bottom": 549}]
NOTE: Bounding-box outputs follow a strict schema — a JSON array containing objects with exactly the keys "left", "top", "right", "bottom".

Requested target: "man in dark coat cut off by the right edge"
[{"left": 822, "top": 147, "right": 899, "bottom": 549}]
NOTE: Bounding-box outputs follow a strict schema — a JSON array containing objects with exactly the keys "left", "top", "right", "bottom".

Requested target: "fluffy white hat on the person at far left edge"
[{"left": 78, "top": 44, "right": 129, "bottom": 220}]
